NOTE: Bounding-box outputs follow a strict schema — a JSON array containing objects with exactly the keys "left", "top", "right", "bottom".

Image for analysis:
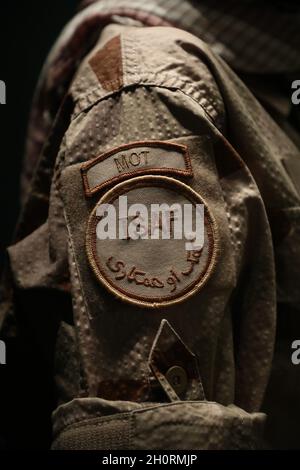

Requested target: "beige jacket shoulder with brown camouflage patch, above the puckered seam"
[{"left": 71, "top": 25, "right": 223, "bottom": 121}]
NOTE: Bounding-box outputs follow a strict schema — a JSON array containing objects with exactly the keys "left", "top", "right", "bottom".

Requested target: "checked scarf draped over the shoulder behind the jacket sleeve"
[{"left": 21, "top": 0, "right": 300, "bottom": 203}]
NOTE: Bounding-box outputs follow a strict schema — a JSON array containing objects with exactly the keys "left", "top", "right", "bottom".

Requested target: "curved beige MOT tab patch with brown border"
[{"left": 81, "top": 140, "right": 193, "bottom": 197}]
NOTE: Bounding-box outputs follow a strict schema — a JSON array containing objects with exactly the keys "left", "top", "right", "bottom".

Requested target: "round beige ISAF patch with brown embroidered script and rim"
[{"left": 86, "top": 176, "right": 218, "bottom": 308}]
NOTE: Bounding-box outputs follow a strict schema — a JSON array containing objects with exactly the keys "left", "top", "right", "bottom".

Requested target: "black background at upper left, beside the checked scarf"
[{"left": 0, "top": 0, "right": 79, "bottom": 271}]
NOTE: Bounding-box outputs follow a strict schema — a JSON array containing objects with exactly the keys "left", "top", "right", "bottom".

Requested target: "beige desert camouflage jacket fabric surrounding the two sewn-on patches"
[{"left": 0, "top": 0, "right": 300, "bottom": 449}]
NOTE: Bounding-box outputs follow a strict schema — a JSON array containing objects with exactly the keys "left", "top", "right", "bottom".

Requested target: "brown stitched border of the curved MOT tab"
[{"left": 81, "top": 140, "right": 193, "bottom": 197}]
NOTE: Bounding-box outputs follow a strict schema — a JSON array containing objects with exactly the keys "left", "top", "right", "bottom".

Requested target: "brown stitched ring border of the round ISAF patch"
[{"left": 86, "top": 176, "right": 219, "bottom": 309}]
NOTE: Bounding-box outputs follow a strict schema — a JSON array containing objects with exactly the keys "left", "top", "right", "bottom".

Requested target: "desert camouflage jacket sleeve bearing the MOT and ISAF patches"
[{"left": 1, "top": 25, "right": 282, "bottom": 449}]
